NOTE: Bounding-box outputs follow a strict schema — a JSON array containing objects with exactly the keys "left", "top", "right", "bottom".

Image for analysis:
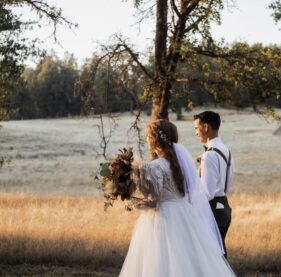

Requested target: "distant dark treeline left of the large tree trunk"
[{"left": 5, "top": 56, "right": 142, "bottom": 119}]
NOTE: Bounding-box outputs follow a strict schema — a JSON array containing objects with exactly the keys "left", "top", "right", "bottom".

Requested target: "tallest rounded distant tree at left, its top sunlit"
[{"left": 30, "top": 56, "right": 80, "bottom": 118}]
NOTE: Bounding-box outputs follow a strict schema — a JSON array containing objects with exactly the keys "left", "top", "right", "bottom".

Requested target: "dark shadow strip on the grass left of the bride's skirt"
[{"left": 0, "top": 236, "right": 127, "bottom": 268}]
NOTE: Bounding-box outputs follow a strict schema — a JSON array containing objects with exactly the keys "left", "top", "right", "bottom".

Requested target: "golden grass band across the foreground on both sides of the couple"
[{"left": 0, "top": 193, "right": 281, "bottom": 276}]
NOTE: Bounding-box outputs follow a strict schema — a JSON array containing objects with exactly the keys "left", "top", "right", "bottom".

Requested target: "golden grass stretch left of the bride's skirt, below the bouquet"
[{"left": 0, "top": 192, "right": 136, "bottom": 266}]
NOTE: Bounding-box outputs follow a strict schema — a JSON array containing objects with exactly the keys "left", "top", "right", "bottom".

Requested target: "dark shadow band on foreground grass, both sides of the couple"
[{"left": 0, "top": 236, "right": 281, "bottom": 277}]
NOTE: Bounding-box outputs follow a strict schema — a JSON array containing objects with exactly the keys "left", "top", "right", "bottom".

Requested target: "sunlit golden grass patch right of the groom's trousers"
[{"left": 227, "top": 193, "right": 281, "bottom": 276}]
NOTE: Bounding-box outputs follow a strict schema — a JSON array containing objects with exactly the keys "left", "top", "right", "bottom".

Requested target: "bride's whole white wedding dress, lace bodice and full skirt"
[{"left": 119, "top": 144, "right": 235, "bottom": 277}]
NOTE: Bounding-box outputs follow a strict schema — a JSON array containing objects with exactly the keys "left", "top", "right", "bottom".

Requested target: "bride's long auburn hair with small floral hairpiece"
[{"left": 146, "top": 119, "right": 184, "bottom": 195}]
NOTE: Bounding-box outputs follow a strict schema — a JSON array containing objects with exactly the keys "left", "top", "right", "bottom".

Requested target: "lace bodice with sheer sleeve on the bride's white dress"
[{"left": 139, "top": 157, "right": 182, "bottom": 206}]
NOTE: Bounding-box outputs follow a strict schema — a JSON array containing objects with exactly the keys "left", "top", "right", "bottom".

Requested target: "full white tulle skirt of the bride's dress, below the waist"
[{"left": 119, "top": 199, "right": 235, "bottom": 277}]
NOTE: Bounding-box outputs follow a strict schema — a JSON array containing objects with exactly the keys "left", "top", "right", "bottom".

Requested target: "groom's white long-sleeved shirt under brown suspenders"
[{"left": 201, "top": 137, "right": 234, "bottom": 200}]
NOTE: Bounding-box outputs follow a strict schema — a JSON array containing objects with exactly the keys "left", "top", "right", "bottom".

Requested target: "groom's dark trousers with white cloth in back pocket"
[{"left": 210, "top": 196, "right": 231, "bottom": 258}]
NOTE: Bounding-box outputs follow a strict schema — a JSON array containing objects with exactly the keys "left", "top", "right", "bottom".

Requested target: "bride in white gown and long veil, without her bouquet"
[{"left": 120, "top": 120, "right": 235, "bottom": 277}]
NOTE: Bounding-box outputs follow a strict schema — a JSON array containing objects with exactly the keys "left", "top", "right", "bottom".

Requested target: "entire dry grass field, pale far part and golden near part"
[{"left": 0, "top": 110, "right": 281, "bottom": 277}]
